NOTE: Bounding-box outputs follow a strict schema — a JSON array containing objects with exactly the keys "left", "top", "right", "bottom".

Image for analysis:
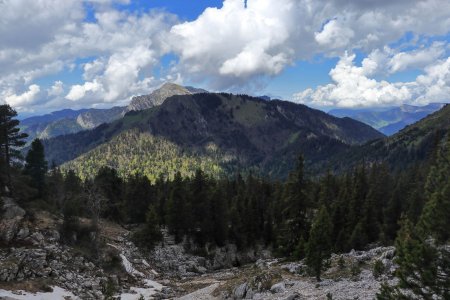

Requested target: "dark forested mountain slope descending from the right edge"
[{"left": 330, "top": 104, "right": 450, "bottom": 170}]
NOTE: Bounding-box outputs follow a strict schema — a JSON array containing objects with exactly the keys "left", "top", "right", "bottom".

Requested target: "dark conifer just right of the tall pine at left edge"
[{"left": 24, "top": 139, "right": 47, "bottom": 197}]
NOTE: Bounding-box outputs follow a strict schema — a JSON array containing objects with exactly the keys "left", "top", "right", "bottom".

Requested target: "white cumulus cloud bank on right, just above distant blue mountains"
[{"left": 294, "top": 54, "right": 450, "bottom": 107}]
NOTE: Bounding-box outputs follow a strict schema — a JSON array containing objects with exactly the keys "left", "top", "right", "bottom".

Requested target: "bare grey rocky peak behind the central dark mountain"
[{"left": 127, "top": 82, "right": 206, "bottom": 111}]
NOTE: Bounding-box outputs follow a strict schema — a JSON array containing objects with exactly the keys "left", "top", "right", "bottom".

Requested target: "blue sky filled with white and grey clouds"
[{"left": 0, "top": 0, "right": 450, "bottom": 115}]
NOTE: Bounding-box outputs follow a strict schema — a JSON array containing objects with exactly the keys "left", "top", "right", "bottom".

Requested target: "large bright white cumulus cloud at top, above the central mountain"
[{"left": 171, "top": 0, "right": 295, "bottom": 88}]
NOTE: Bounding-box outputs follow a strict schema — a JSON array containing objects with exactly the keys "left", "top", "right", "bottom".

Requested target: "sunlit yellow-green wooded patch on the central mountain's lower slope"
[{"left": 62, "top": 130, "right": 227, "bottom": 182}]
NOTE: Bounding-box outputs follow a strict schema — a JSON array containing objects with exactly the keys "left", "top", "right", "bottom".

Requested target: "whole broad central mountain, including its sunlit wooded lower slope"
[{"left": 45, "top": 93, "right": 383, "bottom": 177}]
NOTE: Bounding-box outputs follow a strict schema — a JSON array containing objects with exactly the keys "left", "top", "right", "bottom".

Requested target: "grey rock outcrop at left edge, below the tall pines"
[{"left": 0, "top": 197, "right": 25, "bottom": 244}]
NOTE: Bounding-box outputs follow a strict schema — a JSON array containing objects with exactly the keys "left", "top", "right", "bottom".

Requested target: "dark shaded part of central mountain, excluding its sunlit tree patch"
[{"left": 45, "top": 93, "right": 383, "bottom": 176}]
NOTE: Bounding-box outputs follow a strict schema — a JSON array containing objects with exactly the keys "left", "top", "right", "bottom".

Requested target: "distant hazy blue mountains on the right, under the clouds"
[{"left": 329, "top": 103, "right": 445, "bottom": 135}]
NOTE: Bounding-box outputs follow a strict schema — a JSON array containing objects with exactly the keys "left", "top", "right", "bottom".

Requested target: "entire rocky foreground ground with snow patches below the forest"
[{"left": 0, "top": 198, "right": 394, "bottom": 300}]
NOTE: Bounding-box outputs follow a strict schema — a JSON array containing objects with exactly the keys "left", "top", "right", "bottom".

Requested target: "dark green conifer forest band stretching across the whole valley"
[{"left": 0, "top": 105, "right": 450, "bottom": 299}]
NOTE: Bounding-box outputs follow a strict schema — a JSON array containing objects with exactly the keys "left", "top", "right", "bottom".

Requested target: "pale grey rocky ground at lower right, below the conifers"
[{"left": 178, "top": 247, "right": 395, "bottom": 300}]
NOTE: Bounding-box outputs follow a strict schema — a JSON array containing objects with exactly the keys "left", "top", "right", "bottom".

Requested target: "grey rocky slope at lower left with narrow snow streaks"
[{"left": 0, "top": 203, "right": 167, "bottom": 299}]
